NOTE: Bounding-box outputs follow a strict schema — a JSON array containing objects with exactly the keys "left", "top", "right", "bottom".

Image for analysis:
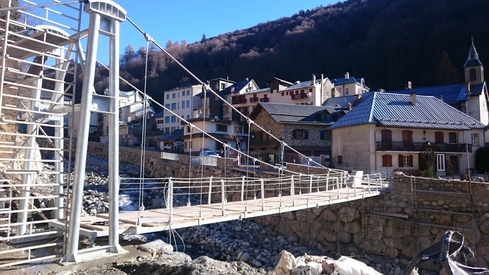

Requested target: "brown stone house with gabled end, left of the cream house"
[{"left": 249, "top": 103, "right": 346, "bottom": 165}]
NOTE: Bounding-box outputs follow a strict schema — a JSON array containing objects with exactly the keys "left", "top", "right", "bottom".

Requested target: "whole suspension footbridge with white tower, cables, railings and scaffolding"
[{"left": 0, "top": 0, "right": 387, "bottom": 268}]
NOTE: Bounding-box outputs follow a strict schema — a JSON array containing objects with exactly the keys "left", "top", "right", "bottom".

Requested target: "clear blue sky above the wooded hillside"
[{"left": 110, "top": 0, "right": 342, "bottom": 54}]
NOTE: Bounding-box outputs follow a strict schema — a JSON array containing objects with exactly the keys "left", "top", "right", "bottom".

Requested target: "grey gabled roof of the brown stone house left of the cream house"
[{"left": 250, "top": 102, "right": 329, "bottom": 124}]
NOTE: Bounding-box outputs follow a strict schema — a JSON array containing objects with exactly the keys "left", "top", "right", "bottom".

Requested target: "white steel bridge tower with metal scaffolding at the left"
[{"left": 0, "top": 0, "right": 125, "bottom": 268}]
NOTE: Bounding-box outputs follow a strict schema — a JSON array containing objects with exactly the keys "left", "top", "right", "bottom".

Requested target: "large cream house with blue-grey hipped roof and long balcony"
[{"left": 330, "top": 92, "right": 485, "bottom": 176}]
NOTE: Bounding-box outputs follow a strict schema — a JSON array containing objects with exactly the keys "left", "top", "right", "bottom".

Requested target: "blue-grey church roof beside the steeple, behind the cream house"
[{"left": 389, "top": 82, "right": 486, "bottom": 105}]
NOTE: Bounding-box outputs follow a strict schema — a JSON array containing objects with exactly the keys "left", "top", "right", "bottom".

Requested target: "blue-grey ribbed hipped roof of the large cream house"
[{"left": 330, "top": 92, "right": 485, "bottom": 130}]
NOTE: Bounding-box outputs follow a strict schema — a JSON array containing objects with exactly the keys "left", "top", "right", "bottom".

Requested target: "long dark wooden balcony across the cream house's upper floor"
[{"left": 376, "top": 141, "right": 472, "bottom": 153}]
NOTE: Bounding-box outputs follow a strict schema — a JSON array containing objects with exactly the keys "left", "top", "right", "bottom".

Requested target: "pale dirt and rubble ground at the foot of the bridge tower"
[{"left": 0, "top": 242, "right": 273, "bottom": 275}]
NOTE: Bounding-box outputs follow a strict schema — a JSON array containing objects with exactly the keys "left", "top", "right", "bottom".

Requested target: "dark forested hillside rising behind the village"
[{"left": 93, "top": 0, "right": 489, "bottom": 102}]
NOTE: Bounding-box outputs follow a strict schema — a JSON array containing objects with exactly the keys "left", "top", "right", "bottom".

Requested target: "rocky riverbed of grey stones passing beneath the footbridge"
[{"left": 22, "top": 158, "right": 422, "bottom": 275}]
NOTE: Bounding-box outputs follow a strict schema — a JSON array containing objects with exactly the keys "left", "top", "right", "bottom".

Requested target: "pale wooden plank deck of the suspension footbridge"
[{"left": 81, "top": 187, "right": 386, "bottom": 233}]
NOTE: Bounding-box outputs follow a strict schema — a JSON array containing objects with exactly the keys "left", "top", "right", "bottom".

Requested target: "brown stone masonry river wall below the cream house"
[{"left": 256, "top": 175, "right": 489, "bottom": 270}]
